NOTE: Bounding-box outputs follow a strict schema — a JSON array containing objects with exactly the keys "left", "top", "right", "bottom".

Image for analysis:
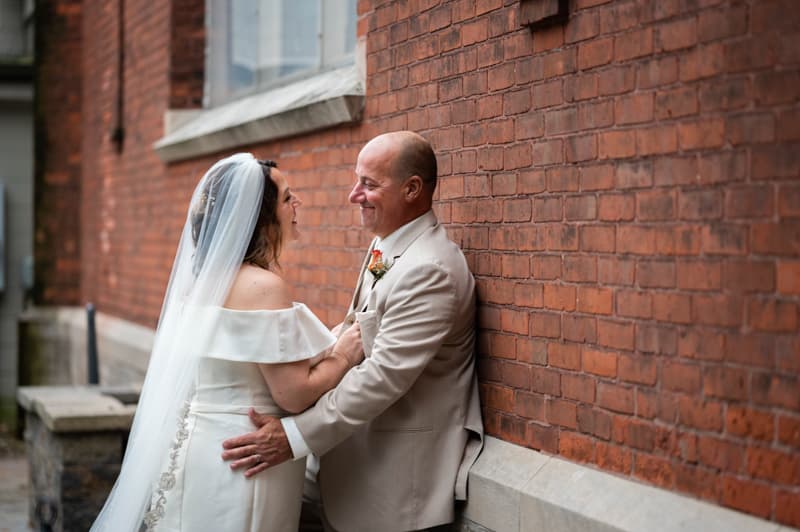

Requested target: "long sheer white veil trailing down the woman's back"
[{"left": 91, "top": 153, "right": 264, "bottom": 532}]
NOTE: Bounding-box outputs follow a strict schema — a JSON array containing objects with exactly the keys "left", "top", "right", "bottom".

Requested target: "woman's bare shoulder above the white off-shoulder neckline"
[{"left": 225, "top": 264, "right": 292, "bottom": 310}]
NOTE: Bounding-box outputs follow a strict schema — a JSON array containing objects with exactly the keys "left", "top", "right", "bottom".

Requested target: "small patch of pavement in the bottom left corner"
[{"left": 0, "top": 426, "right": 33, "bottom": 532}]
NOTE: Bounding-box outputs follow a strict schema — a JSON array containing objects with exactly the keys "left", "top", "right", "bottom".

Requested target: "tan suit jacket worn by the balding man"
[{"left": 295, "top": 212, "right": 483, "bottom": 532}]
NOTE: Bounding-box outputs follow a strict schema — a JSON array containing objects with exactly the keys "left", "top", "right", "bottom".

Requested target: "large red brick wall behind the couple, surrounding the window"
[{"left": 39, "top": 0, "right": 800, "bottom": 526}]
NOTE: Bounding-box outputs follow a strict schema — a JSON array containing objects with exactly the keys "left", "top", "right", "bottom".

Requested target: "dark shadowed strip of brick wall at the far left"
[{"left": 34, "top": 0, "right": 82, "bottom": 305}]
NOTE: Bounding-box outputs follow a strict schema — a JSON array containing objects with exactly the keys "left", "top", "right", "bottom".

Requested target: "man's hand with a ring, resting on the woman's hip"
[{"left": 222, "top": 408, "right": 293, "bottom": 477}]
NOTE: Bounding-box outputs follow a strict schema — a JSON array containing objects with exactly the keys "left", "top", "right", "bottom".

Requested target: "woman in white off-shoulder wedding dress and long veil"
[{"left": 92, "top": 154, "right": 363, "bottom": 532}]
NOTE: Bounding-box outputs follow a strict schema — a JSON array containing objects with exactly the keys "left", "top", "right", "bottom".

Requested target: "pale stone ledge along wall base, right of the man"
[{"left": 464, "top": 437, "right": 794, "bottom": 532}]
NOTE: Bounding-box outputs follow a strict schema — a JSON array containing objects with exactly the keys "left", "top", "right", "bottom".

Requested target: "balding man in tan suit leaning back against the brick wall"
[{"left": 223, "top": 131, "right": 483, "bottom": 532}]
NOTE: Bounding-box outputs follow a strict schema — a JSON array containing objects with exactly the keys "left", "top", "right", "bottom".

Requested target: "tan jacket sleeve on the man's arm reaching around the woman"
[{"left": 295, "top": 264, "right": 457, "bottom": 455}]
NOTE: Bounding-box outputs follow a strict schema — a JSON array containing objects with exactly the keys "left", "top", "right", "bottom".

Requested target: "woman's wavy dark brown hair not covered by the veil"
[{"left": 244, "top": 159, "right": 283, "bottom": 270}]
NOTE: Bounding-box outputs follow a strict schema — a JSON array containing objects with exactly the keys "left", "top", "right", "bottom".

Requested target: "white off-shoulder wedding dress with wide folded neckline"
[{"left": 148, "top": 303, "right": 335, "bottom": 532}]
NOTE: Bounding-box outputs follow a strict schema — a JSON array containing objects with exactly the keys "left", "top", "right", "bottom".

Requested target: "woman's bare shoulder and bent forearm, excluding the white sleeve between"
[{"left": 225, "top": 265, "right": 364, "bottom": 413}]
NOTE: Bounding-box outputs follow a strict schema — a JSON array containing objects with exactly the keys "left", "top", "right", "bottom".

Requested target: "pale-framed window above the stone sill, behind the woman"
[{"left": 205, "top": 0, "right": 356, "bottom": 107}]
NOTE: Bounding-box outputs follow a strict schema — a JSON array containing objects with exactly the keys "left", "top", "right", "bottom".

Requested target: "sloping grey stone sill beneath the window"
[{"left": 154, "top": 65, "right": 364, "bottom": 162}]
